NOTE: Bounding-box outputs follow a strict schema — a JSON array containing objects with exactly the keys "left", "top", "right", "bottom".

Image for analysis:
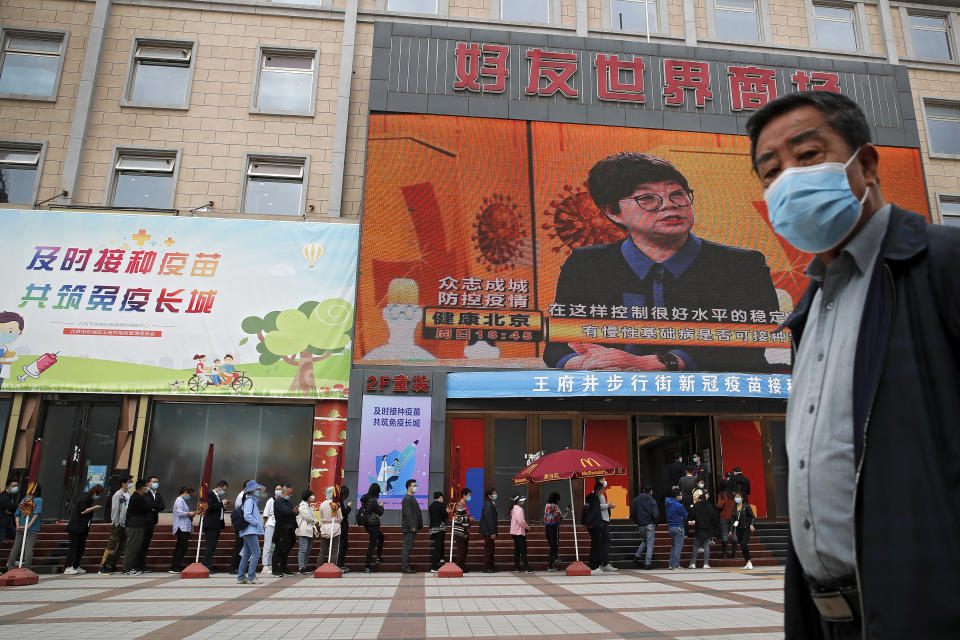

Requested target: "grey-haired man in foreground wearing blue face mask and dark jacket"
[{"left": 747, "top": 91, "right": 960, "bottom": 640}]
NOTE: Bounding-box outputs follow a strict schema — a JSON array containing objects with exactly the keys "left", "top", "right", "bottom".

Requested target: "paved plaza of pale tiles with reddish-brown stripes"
[{"left": 0, "top": 567, "right": 783, "bottom": 640}]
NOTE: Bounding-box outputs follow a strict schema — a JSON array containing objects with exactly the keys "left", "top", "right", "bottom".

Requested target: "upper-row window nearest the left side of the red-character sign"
[{"left": 251, "top": 50, "right": 320, "bottom": 116}]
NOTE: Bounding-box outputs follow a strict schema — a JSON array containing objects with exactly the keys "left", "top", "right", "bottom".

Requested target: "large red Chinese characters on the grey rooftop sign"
[{"left": 453, "top": 42, "right": 840, "bottom": 111}]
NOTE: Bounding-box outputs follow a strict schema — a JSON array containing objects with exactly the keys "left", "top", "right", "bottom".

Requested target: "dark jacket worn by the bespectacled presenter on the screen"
[{"left": 543, "top": 239, "right": 780, "bottom": 373}]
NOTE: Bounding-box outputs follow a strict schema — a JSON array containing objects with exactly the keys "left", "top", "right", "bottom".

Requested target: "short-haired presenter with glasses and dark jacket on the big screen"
[{"left": 543, "top": 153, "right": 780, "bottom": 372}]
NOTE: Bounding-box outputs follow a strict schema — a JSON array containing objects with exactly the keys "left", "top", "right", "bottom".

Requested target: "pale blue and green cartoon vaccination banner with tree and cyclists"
[{"left": 0, "top": 211, "right": 358, "bottom": 398}]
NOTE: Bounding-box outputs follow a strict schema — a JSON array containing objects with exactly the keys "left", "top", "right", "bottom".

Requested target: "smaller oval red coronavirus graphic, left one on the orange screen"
[{"left": 473, "top": 193, "right": 530, "bottom": 271}]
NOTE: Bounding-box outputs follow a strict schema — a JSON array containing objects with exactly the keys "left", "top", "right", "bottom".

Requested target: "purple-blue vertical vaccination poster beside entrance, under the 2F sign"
[{"left": 358, "top": 395, "right": 431, "bottom": 509}]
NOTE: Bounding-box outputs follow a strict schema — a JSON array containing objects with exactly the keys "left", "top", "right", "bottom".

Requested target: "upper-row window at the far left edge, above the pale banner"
[{"left": 0, "top": 31, "right": 66, "bottom": 100}]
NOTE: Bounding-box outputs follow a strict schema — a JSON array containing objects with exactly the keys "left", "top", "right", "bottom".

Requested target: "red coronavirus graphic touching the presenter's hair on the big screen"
[{"left": 543, "top": 185, "right": 627, "bottom": 253}]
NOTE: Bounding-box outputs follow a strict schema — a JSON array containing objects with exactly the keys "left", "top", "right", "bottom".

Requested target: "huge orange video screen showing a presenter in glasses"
[{"left": 354, "top": 114, "right": 929, "bottom": 375}]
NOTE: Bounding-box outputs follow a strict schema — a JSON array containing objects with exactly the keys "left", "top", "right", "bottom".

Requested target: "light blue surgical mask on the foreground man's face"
[{"left": 763, "top": 149, "right": 870, "bottom": 253}]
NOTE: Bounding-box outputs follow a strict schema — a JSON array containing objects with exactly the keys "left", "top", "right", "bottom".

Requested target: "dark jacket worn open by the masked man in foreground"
[{"left": 784, "top": 206, "right": 960, "bottom": 640}]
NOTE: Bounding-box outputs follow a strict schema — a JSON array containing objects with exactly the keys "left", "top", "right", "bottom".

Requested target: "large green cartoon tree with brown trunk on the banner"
[{"left": 241, "top": 298, "right": 353, "bottom": 395}]
